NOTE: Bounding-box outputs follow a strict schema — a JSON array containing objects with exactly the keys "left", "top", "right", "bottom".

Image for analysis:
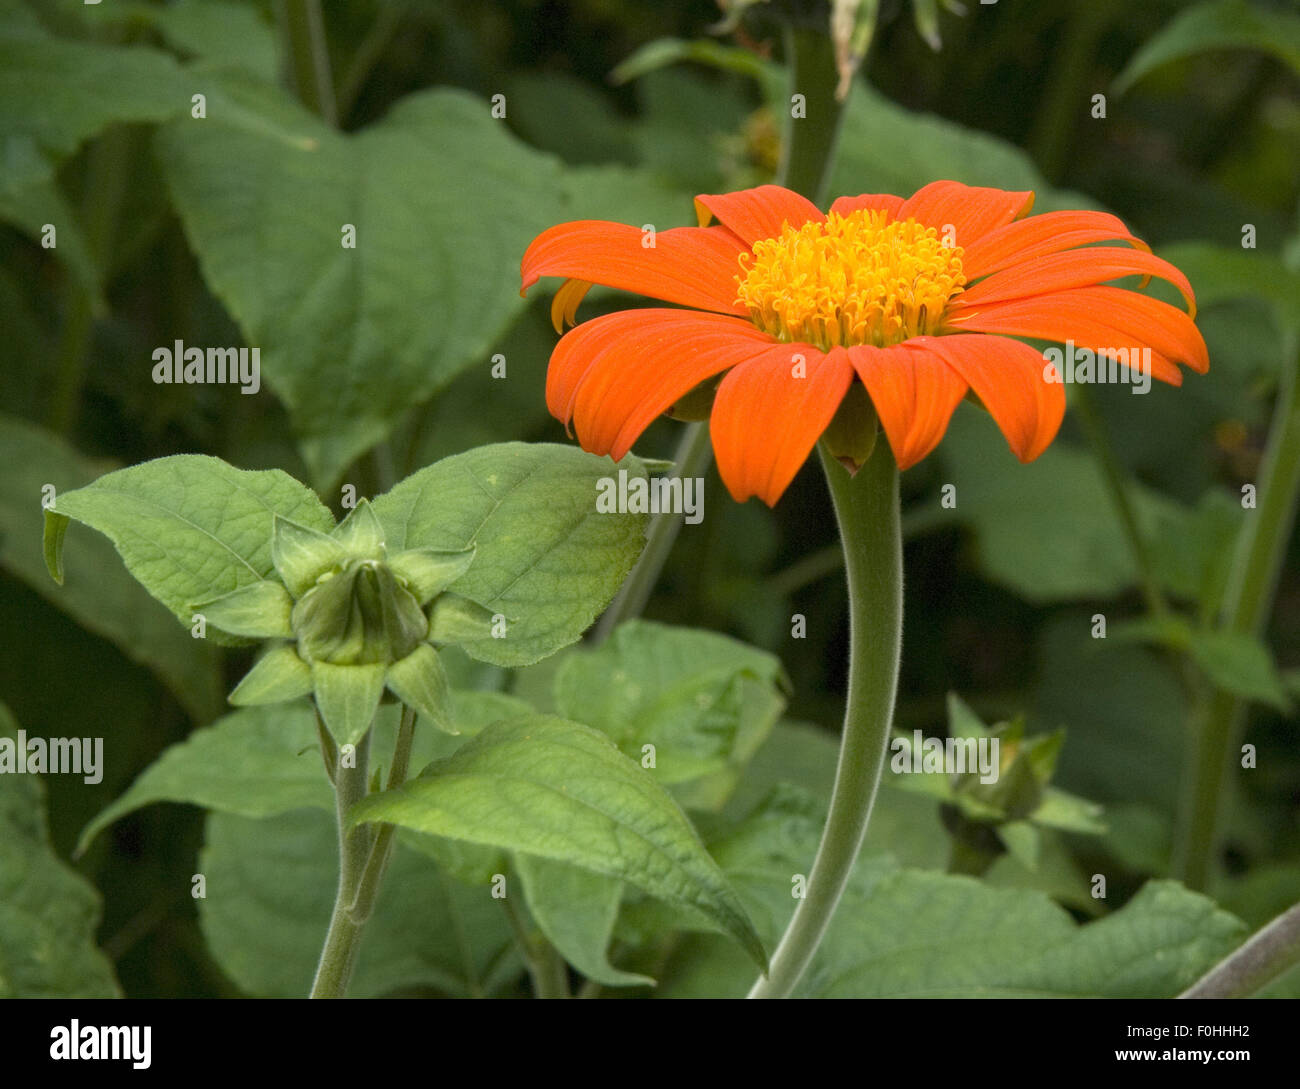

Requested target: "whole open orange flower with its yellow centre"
[{"left": 520, "top": 182, "right": 1209, "bottom": 504}]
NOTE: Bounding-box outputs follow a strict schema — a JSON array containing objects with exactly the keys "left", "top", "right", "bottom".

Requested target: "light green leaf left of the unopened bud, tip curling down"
[{"left": 46, "top": 454, "right": 334, "bottom": 642}]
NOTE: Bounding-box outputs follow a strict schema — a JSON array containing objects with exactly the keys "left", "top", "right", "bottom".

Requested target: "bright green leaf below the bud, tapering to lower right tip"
[{"left": 351, "top": 715, "right": 766, "bottom": 966}]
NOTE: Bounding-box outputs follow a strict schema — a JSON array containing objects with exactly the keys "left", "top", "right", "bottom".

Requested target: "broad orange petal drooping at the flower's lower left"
[{"left": 546, "top": 309, "right": 772, "bottom": 460}]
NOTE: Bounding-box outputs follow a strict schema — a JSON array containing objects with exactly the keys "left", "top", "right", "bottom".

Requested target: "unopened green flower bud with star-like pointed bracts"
[{"left": 194, "top": 499, "right": 475, "bottom": 745}]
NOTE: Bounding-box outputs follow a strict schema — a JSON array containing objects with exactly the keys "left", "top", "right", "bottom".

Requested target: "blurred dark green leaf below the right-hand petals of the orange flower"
[{"left": 940, "top": 405, "right": 1174, "bottom": 604}]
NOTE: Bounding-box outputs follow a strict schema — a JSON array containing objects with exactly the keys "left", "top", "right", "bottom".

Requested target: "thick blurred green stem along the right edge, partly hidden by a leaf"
[{"left": 1174, "top": 333, "right": 1300, "bottom": 889}]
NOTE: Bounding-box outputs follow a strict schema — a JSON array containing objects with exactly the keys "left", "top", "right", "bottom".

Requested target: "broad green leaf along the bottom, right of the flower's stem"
[{"left": 801, "top": 871, "right": 1245, "bottom": 998}]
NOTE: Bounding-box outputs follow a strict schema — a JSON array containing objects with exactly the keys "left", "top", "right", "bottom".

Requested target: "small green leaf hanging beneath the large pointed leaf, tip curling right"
[{"left": 515, "top": 855, "right": 654, "bottom": 986}]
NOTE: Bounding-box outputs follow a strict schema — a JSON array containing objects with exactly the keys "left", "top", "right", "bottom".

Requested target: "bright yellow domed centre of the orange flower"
[{"left": 736, "top": 209, "right": 966, "bottom": 348}]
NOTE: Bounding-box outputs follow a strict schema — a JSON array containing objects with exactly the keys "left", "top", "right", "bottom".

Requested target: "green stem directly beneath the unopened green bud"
[{"left": 311, "top": 730, "right": 374, "bottom": 998}]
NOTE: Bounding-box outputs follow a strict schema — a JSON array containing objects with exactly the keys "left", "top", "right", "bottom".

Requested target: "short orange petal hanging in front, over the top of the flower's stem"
[{"left": 849, "top": 343, "right": 967, "bottom": 469}]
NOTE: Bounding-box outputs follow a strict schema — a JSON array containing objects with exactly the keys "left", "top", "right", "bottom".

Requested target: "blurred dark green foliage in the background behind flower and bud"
[{"left": 0, "top": 0, "right": 1300, "bottom": 995}]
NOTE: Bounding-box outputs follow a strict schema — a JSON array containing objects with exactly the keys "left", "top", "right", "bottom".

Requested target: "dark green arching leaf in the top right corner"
[{"left": 1114, "top": 0, "right": 1300, "bottom": 95}]
